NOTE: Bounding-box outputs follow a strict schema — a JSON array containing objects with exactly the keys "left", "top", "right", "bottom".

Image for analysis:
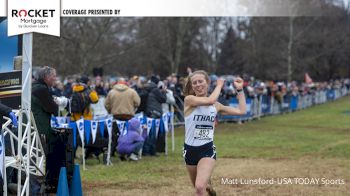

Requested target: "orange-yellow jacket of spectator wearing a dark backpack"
[{"left": 71, "top": 84, "right": 98, "bottom": 121}]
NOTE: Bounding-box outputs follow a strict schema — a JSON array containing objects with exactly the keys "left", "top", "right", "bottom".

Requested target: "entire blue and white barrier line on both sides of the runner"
[{"left": 47, "top": 87, "right": 350, "bottom": 169}]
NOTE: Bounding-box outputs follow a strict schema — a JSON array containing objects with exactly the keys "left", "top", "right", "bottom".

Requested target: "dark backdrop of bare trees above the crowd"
[{"left": 33, "top": 11, "right": 350, "bottom": 81}]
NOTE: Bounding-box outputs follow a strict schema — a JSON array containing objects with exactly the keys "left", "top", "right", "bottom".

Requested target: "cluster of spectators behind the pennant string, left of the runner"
[{"left": 50, "top": 74, "right": 183, "bottom": 161}]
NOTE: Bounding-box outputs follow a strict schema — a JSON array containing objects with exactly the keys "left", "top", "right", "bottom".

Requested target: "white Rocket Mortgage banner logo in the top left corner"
[{"left": 7, "top": 0, "right": 61, "bottom": 36}]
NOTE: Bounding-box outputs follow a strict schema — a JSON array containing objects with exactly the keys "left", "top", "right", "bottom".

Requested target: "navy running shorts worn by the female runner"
[{"left": 183, "top": 142, "right": 216, "bottom": 165}]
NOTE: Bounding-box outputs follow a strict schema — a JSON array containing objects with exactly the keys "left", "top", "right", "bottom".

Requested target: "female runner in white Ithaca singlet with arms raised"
[{"left": 183, "top": 70, "right": 246, "bottom": 195}]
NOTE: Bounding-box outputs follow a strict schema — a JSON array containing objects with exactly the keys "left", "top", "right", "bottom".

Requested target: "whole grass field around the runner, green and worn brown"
[{"left": 81, "top": 96, "right": 350, "bottom": 195}]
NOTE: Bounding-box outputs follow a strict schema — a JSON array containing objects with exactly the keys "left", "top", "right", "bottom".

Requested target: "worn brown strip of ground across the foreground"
[{"left": 83, "top": 158, "right": 350, "bottom": 196}]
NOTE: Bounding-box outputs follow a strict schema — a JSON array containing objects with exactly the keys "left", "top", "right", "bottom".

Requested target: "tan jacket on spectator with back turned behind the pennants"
[{"left": 105, "top": 84, "right": 140, "bottom": 116}]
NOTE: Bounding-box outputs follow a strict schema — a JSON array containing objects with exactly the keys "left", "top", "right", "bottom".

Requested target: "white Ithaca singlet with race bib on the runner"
[{"left": 185, "top": 105, "right": 217, "bottom": 146}]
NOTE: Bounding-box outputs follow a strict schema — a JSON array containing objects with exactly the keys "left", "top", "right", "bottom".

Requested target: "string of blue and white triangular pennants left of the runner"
[{"left": 51, "top": 112, "right": 175, "bottom": 170}]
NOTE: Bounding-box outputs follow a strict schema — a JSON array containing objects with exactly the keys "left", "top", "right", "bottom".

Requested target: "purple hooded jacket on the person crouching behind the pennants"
[{"left": 117, "top": 118, "right": 144, "bottom": 155}]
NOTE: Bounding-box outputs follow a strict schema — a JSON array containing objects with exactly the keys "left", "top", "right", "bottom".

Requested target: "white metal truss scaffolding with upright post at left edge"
[{"left": 2, "top": 33, "right": 46, "bottom": 196}]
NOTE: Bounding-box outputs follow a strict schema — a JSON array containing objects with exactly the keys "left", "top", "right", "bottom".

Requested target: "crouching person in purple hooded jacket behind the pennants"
[{"left": 117, "top": 118, "right": 144, "bottom": 161}]
